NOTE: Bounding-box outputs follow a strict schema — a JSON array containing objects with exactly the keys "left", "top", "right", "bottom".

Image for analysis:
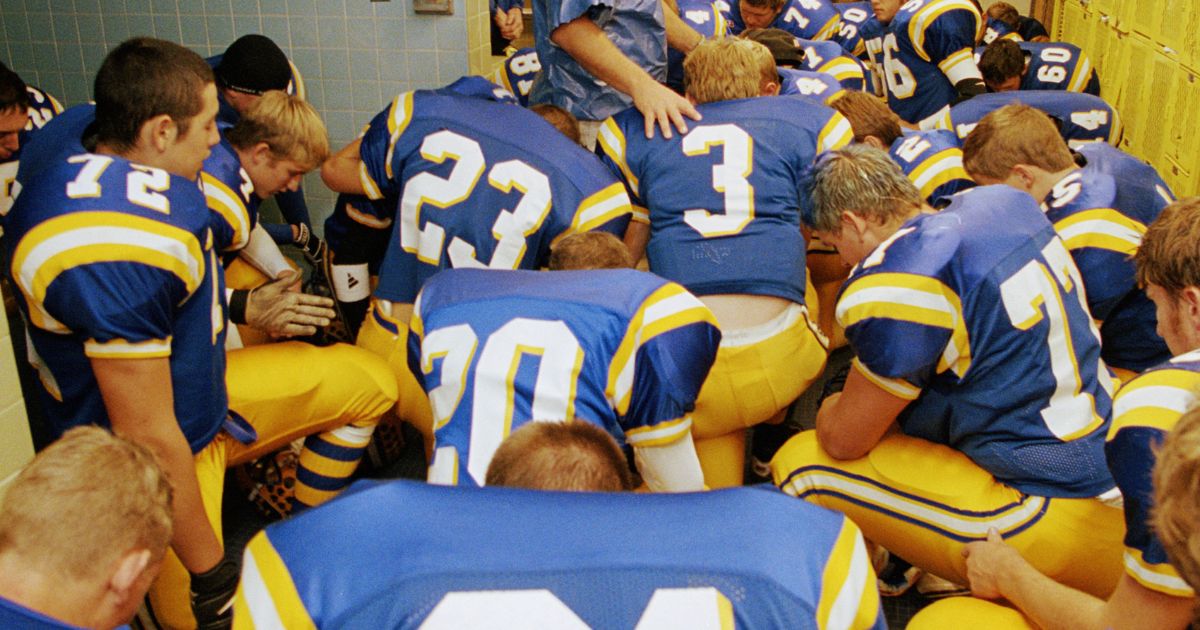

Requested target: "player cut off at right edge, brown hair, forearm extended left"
[{"left": 931, "top": 198, "right": 1200, "bottom": 630}]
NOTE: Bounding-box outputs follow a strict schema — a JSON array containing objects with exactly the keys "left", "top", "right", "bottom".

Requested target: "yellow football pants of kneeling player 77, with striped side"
[{"left": 770, "top": 431, "right": 1124, "bottom": 599}]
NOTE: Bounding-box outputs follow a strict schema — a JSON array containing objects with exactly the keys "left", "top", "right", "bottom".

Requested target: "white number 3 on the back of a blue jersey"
[{"left": 680, "top": 124, "right": 754, "bottom": 238}]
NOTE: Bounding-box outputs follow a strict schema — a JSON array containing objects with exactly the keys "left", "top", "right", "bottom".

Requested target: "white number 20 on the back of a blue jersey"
[{"left": 421, "top": 317, "right": 583, "bottom": 486}]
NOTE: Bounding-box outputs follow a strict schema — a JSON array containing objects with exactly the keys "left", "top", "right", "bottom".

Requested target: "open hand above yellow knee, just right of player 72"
[{"left": 246, "top": 270, "right": 337, "bottom": 337}]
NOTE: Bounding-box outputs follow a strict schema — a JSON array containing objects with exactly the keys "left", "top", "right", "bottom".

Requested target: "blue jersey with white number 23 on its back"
[{"left": 360, "top": 90, "right": 631, "bottom": 304}]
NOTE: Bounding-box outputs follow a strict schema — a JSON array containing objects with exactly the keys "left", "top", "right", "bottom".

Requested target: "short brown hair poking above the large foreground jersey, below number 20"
[{"left": 486, "top": 419, "right": 634, "bottom": 492}]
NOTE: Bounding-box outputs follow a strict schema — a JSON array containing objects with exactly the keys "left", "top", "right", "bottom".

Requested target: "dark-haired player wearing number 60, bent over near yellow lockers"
[{"left": 976, "top": 40, "right": 1100, "bottom": 96}]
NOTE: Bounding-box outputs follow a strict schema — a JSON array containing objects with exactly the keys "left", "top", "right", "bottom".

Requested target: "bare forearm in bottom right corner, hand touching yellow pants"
[{"left": 962, "top": 530, "right": 1195, "bottom": 630}]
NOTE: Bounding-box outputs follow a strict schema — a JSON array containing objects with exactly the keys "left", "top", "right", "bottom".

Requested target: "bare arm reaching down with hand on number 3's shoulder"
[{"left": 549, "top": 16, "right": 700, "bottom": 137}]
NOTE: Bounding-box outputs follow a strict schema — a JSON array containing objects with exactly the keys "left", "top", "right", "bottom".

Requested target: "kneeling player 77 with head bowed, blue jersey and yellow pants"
[{"left": 772, "top": 145, "right": 1122, "bottom": 595}]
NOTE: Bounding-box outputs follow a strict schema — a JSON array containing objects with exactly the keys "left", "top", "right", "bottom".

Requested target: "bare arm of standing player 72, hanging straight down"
[{"left": 91, "top": 358, "right": 223, "bottom": 574}]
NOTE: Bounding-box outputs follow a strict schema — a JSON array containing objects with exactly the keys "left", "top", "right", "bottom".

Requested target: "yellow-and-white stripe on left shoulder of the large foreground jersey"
[{"left": 233, "top": 532, "right": 317, "bottom": 630}]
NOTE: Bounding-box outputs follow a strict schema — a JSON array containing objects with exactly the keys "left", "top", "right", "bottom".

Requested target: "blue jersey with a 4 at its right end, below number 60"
[{"left": 937, "top": 90, "right": 1122, "bottom": 149}]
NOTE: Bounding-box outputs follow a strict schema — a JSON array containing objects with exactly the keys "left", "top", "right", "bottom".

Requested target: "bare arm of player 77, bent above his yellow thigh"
[{"left": 817, "top": 360, "right": 908, "bottom": 460}]
